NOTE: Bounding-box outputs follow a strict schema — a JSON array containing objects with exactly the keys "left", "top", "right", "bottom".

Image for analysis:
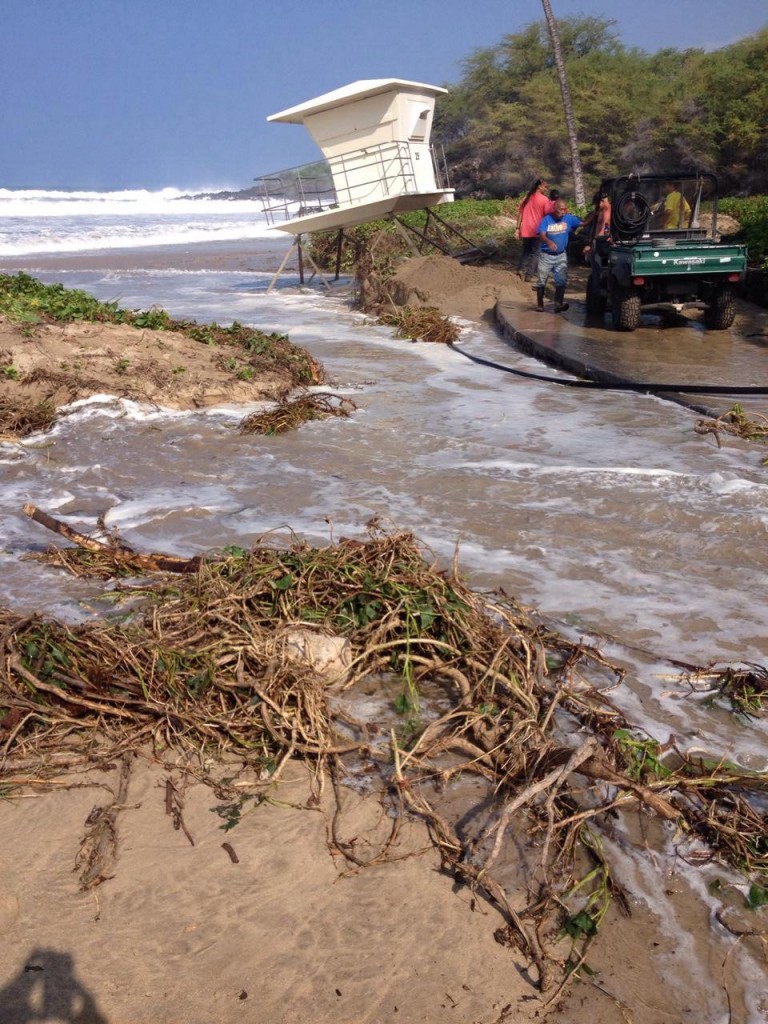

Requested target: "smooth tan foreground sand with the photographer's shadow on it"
[{"left": 0, "top": 758, "right": 552, "bottom": 1024}]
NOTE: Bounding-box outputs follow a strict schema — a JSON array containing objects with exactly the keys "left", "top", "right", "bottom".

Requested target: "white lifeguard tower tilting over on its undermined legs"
[{"left": 255, "top": 78, "right": 488, "bottom": 287}]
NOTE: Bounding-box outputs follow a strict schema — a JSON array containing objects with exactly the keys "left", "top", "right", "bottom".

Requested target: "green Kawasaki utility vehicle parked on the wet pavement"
[{"left": 587, "top": 172, "right": 746, "bottom": 331}]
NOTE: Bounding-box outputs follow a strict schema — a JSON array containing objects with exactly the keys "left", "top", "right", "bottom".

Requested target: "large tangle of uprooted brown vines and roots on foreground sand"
[{"left": 0, "top": 516, "right": 768, "bottom": 990}]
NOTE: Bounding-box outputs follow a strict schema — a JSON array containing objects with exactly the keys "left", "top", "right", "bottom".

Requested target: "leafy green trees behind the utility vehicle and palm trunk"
[{"left": 432, "top": 16, "right": 768, "bottom": 198}]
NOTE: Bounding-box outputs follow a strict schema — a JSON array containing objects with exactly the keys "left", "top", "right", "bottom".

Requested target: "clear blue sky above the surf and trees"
[{"left": 0, "top": 0, "right": 768, "bottom": 188}]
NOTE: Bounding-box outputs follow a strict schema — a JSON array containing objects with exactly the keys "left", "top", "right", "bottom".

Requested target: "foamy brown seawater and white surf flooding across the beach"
[{"left": 0, "top": 191, "right": 768, "bottom": 1021}]
